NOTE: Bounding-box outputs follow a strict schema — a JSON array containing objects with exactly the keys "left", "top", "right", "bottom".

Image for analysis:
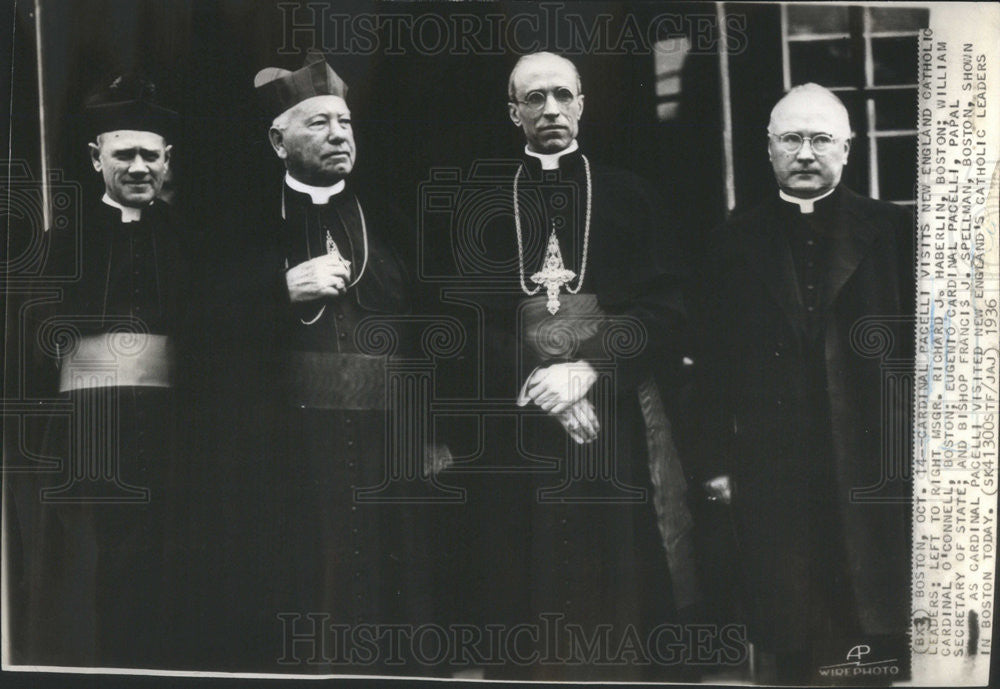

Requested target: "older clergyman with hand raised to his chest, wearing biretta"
[{"left": 191, "top": 54, "right": 430, "bottom": 673}]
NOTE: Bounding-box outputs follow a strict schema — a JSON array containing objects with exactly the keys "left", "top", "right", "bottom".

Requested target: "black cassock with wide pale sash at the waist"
[{"left": 11, "top": 201, "right": 187, "bottom": 667}]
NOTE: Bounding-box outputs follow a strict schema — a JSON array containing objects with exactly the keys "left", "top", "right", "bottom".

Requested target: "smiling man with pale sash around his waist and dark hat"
[{"left": 14, "top": 75, "right": 190, "bottom": 667}]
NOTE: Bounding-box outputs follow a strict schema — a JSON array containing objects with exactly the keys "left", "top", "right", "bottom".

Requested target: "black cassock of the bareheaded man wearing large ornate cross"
[{"left": 445, "top": 152, "right": 697, "bottom": 679}]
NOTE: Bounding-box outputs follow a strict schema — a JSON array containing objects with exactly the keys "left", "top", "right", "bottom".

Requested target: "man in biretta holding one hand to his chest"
[{"left": 205, "top": 53, "right": 428, "bottom": 672}]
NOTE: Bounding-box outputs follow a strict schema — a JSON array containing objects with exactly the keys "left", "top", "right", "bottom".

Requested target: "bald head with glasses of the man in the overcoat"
[{"left": 767, "top": 84, "right": 851, "bottom": 198}]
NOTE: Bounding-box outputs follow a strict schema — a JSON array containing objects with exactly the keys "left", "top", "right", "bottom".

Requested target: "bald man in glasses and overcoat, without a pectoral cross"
[{"left": 692, "top": 84, "right": 914, "bottom": 683}]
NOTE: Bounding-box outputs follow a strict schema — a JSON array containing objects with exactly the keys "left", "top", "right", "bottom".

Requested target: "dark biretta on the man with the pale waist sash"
[{"left": 83, "top": 74, "right": 178, "bottom": 141}]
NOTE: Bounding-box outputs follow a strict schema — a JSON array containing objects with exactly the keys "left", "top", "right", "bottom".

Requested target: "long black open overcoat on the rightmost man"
[{"left": 690, "top": 187, "right": 914, "bottom": 647}]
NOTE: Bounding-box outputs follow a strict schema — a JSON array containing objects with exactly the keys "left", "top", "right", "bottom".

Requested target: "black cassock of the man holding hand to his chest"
[{"left": 200, "top": 184, "right": 430, "bottom": 673}]
